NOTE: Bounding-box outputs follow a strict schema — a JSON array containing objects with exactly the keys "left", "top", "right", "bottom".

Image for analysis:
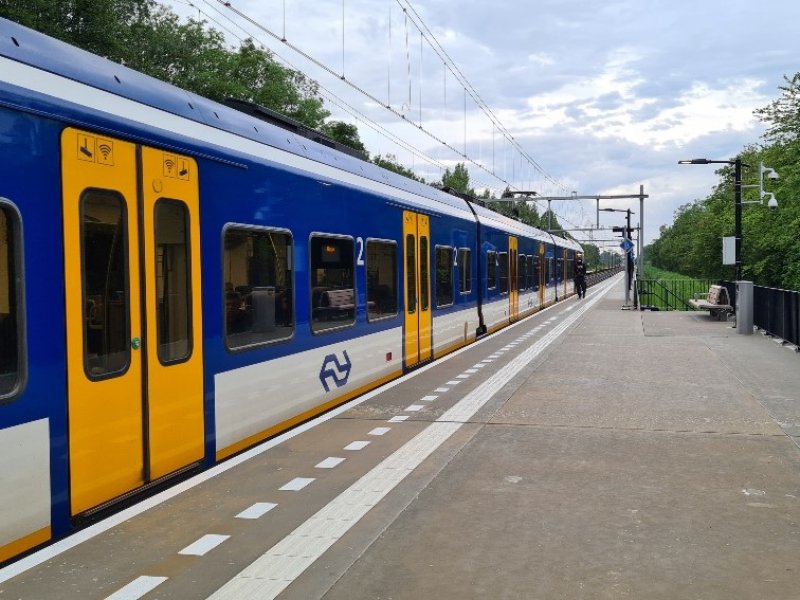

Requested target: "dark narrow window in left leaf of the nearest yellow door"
[{"left": 81, "top": 189, "right": 131, "bottom": 379}]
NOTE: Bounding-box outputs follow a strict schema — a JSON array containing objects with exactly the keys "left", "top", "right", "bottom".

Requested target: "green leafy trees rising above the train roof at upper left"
[{"left": 0, "top": 0, "right": 332, "bottom": 131}]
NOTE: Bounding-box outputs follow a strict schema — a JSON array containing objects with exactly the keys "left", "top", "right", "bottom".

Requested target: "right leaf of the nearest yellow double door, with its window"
[{"left": 142, "top": 148, "right": 203, "bottom": 479}]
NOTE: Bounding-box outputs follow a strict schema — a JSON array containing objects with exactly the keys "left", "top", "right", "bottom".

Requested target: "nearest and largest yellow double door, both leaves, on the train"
[{"left": 61, "top": 129, "right": 203, "bottom": 514}]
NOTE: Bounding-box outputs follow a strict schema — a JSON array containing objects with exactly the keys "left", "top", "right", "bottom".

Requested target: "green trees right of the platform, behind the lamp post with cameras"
[{"left": 645, "top": 102, "right": 800, "bottom": 290}]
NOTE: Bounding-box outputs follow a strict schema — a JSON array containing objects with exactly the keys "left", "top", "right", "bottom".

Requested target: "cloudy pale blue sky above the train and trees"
[{"left": 163, "top": 0, "right": 800, "bottom": 248}]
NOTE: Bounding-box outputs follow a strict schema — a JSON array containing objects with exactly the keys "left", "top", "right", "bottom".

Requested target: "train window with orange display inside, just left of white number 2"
[{"left": 310, "top": 235, "right": 356, "bottom": 333}]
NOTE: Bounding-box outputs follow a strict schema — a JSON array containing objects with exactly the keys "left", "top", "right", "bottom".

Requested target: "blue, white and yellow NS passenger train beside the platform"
[{"left": 0, "top": 19, "right": 580, "bottom": 562}]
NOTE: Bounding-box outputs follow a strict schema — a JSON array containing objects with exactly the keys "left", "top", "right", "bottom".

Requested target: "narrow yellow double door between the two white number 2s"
[{"left": 403, "top": 211, "right": 433, "bottom": 367}]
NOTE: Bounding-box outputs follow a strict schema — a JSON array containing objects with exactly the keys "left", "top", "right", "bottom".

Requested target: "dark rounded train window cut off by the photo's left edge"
[{"left": 0, "top": 204, "right": 25, "bottom": 400}]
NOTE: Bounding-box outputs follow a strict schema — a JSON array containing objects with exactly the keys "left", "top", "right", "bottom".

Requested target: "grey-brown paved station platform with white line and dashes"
[{"left": 0, "top": 278, "right": 800, "bottom": 600}]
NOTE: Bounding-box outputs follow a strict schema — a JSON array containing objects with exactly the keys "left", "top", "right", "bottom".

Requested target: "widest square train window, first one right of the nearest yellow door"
[{"left": 222, "top": 227, "right": 294, "bottom": 350}]
